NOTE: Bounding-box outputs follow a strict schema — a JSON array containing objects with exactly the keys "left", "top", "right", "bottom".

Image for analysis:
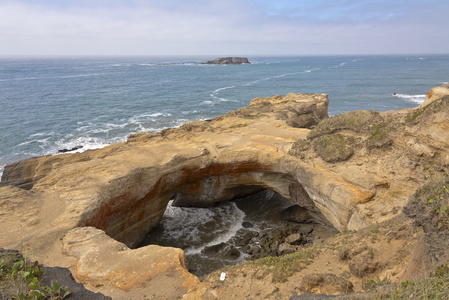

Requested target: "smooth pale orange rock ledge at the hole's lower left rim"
[{"left": 62, "top": 227, "right": 199, "bottom": 298}]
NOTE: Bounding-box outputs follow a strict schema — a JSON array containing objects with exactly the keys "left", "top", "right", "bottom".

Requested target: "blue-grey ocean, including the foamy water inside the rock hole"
[{"left": 0, "top": 55, "right": 449, "bottom": 275}]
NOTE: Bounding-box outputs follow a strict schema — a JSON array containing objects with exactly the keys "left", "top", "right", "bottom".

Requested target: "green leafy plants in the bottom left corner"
[{"left": 0, "top": 253, "right": 71, "bottom": 300}]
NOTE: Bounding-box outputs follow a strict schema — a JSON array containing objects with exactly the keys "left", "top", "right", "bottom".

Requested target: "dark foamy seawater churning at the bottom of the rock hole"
[{"left": 141, "top": 190, "right": 336, "bottom": 277}]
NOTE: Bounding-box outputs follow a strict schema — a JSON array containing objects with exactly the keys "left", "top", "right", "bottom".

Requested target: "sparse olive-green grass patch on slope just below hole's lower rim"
[{"left": 245, "top": 248, "right": 316, "bottom": 282}]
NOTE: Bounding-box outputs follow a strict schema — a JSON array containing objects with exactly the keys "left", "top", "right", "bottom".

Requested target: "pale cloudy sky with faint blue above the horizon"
[{"left": 0, "top": 0, "right": 449, "bottom": 56}]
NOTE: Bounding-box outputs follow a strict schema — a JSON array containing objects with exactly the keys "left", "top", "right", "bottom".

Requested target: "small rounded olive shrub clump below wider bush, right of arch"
[{"left": 313, "top": 134, "right": 356, "bottom": 162}]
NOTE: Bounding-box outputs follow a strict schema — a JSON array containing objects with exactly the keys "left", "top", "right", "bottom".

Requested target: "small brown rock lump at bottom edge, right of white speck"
[{"left": 300, "top": 274, "right": 354, "bottom": 295}]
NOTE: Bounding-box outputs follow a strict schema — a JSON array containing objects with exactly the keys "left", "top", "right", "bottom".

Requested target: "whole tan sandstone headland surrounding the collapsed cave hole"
[{"left": 0, "top": 85, "right": 449, "bottom": 299}]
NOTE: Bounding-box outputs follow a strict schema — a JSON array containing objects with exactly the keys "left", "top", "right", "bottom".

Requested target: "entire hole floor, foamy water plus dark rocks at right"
[{"left": 140, "top": 189, "right": 338, "bottom": 277}]
